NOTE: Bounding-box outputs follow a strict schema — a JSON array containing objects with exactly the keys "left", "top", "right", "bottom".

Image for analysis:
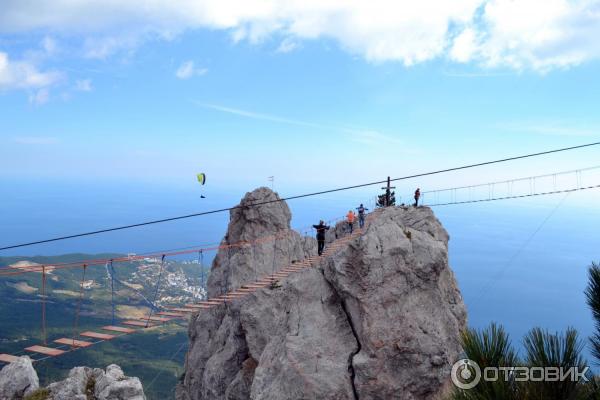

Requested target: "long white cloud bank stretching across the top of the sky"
[{"left": 0, "top": 0, "right": 600, "bottom": 71}]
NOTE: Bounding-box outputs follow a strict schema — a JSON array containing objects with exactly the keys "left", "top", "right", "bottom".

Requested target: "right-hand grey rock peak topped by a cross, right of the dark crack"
[{"left": 322, "top": 207, "right": 466, "bottom": 399}]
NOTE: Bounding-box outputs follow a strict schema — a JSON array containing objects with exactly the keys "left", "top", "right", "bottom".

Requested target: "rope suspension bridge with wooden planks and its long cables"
[{"left": 0, "top": 142, "right": 600, "bottom": 363}]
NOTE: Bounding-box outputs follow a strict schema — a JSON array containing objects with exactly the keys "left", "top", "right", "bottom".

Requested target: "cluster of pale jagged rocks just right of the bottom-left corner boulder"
[{"left": 47, "top": 364, "right": 146, "bottom": 400}]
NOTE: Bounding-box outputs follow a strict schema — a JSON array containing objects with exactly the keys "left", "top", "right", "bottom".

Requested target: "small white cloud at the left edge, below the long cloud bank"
[{"left": 0, "top": 52, "right": 62, "bottom": 91}]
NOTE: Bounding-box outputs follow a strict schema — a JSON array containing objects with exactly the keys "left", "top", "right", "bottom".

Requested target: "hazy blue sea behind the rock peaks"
[{"left": 0, "top": 180, "right": 600, "bottom": 363}]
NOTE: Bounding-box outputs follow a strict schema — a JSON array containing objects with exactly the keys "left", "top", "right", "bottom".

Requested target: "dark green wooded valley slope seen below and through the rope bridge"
[{"left": 0, "top": 254, "right": 193, "bottom": 399}]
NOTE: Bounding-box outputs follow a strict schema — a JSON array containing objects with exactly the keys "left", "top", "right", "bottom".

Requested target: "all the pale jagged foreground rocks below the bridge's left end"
[{"left": 0, "top": 356, "right": 146, "bottom": 400}]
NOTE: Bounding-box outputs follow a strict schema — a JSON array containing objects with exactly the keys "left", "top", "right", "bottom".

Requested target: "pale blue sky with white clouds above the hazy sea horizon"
[{"left": 0, "top": 0, "right": 600, "bottom": 198}]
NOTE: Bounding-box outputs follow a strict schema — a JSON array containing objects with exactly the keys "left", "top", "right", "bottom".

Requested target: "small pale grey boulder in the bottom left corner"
[{"left": 0, "top": 356, "right": 39, "bottom": 400}]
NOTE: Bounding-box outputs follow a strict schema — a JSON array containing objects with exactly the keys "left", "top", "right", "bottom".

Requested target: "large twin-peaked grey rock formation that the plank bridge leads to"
[{"left": 177, "top": 188, "right": 466, "bottom": 400}]
